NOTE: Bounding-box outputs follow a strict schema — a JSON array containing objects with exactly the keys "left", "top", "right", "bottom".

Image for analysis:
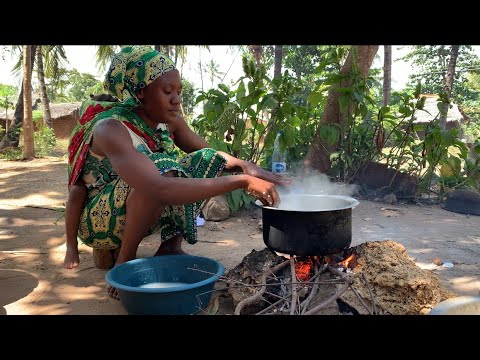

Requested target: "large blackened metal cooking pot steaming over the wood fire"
[{"left": 256, "top": 194, "right": 359, "bottom": 256}]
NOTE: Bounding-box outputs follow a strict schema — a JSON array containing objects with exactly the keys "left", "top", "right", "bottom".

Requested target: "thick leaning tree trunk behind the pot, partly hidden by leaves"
[{"left": 304, "top": 45, "right": 378, "bottom": 173}]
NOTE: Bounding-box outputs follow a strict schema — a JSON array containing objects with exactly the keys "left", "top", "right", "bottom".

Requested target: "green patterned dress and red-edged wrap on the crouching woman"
[{"left": 69, "top": 102, "right": 226, "bottom": 249}]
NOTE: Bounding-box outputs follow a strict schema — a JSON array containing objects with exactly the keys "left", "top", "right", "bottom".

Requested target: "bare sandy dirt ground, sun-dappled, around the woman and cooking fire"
[{"left": 0, "top": 157, "right": 480, "bottom": 315}]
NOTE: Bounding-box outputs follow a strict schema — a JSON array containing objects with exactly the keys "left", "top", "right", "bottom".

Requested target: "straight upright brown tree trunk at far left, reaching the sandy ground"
[{"left": 23, "top": 45, "right": 35, "bottom": 159}]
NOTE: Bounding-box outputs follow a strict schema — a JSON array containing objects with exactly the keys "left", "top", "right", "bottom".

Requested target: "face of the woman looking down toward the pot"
[{"left": 137, "top": 70, "right": 182, "bottom": 125}]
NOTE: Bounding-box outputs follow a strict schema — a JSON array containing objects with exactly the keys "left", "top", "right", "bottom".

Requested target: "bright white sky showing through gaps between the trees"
[{"left": 0, "top": 45, "right": 480, "bottom": 90}]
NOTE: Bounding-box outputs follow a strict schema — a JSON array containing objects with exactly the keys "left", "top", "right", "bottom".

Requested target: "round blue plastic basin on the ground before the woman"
[{"left": 105, "top": 255, "right": 225, "bottom": 315}]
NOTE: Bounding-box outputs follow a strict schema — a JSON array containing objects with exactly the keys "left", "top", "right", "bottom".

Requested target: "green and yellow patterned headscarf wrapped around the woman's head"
[{"left": 103, "top": 45, "right": 175, "bottom": 106}]
